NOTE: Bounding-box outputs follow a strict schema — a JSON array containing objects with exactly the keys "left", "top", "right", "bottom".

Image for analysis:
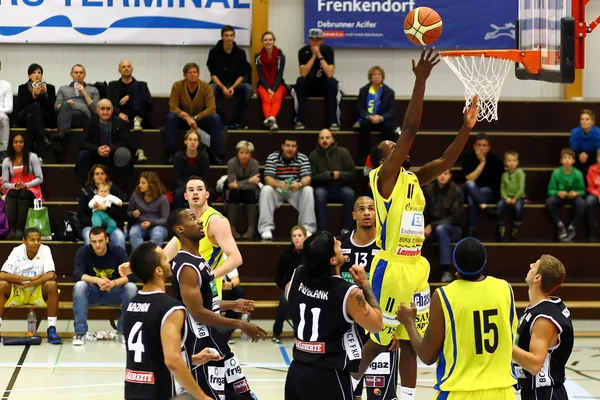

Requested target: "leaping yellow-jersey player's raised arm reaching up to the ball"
[{"left": 378, "top": 48, "right": 440, "bottom": 198}]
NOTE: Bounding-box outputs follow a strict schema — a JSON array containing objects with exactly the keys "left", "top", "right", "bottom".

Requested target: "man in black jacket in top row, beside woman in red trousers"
[{"left": 206, "top": 25, "right": 252, "bottom": 129}]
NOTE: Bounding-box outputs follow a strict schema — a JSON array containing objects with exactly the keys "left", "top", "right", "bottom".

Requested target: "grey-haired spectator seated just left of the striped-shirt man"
[{"left": 225, "top": 140, "right": 260, "bottom": 240}]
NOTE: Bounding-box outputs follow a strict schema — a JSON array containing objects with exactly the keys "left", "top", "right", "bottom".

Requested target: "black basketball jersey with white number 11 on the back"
[{"left": 287, "top": 266, "right": 362, "bottom": 372}]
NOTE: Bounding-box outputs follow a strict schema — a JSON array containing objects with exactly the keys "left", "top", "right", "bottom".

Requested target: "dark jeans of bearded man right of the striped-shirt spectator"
[{"left": 315, "top": 186, "right": 356, "bottom": 231}]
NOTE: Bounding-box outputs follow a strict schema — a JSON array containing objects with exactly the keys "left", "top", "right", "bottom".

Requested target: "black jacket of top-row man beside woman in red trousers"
[{"left": 206, "top": 40, "right": 250, "bottom": 86}]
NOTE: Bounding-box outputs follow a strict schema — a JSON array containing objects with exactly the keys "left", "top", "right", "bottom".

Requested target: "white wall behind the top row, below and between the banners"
[{"left": 0, "top": 0, "right": 600, "bottom": 100}]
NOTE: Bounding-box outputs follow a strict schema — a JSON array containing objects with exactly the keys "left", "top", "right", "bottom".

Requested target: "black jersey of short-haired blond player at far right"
[{"left": 514, "top": 297, "right": 574, "bottom": 395}]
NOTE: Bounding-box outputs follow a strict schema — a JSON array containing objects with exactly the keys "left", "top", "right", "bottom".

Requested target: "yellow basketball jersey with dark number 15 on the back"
[{"left": 434, "top": 276, "right": 518, "bottom": 392}]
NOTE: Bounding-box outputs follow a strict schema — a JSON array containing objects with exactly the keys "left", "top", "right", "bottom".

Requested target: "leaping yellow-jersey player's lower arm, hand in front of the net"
[{"left": 416, "top": 95, "right": 479, "bottom": 185}]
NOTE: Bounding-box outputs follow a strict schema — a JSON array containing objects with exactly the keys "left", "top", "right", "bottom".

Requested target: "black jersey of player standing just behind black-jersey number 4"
[{"left": 171, "top": 250, "right": 230, "bottom": 356}]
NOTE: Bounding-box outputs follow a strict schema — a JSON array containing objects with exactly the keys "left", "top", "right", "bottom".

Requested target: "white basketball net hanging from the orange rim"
[{"left": 442, "top": 55, "right": 515, "bottom": 122}]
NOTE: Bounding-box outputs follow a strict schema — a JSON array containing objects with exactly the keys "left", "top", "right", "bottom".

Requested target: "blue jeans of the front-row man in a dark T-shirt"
[{"left": 73, "top": 281, "right": 137, "bottom": 335}]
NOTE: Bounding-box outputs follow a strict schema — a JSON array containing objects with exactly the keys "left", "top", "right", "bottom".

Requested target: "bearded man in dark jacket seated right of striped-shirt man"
[{"left": 308, "top": 129, "right": 356, "bottom": 234}]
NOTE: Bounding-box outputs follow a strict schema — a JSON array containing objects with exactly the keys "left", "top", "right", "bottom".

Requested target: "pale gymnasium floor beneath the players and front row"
[{"left": 0, "top": 320, "right": 600, "bottom": 400}]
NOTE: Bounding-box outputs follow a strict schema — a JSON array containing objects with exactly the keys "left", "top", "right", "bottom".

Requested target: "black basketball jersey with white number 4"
[{"left": 123, "top": 291, "right": 186, "bottom": 400}]
